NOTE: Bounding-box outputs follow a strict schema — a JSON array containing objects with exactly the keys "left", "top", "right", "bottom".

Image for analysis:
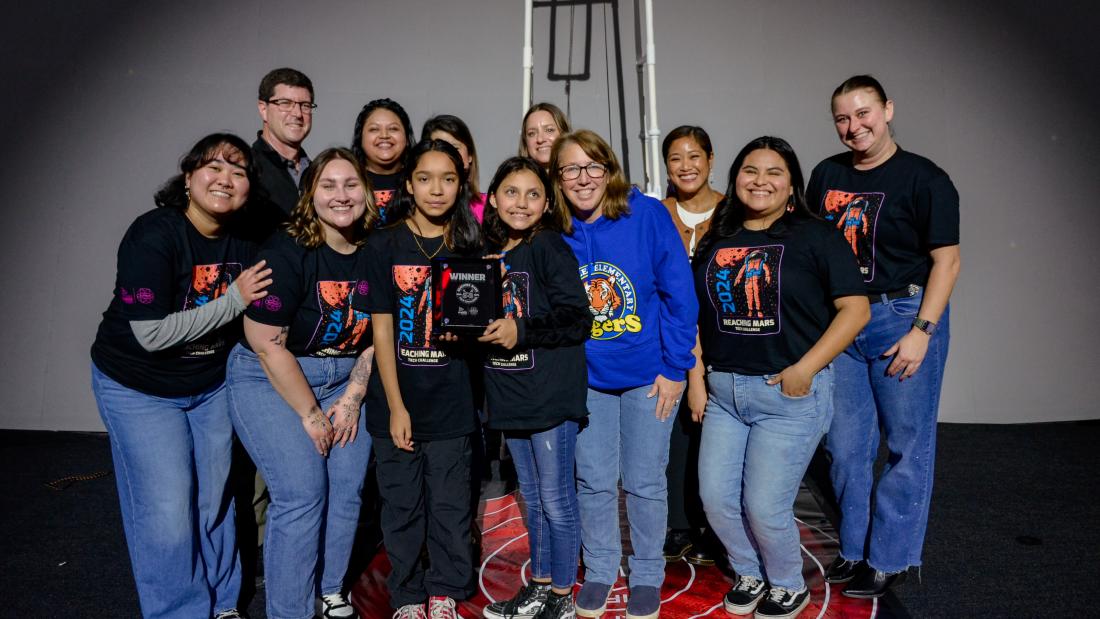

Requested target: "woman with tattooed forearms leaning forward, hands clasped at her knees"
[{"left": 228, "top": 148, "right": 376, "bottom": 617}]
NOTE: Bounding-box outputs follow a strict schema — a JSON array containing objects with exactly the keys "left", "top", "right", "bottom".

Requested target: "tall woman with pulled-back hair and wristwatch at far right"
[{"left": 806, "top": 75, "right": 959, "bottom": 598}]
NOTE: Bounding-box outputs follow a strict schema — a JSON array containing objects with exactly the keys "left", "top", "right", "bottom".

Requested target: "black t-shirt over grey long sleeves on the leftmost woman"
[{"left": 91, "top": 208, "right": 256, "bottom": 397}]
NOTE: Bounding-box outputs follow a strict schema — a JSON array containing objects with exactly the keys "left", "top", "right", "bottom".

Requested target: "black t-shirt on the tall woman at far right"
[{"left": 806, "top": 148, "right": 959, "bottom": 295}]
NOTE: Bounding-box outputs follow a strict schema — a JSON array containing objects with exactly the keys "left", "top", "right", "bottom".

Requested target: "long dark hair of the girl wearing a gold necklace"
[{"left": 389, "top": 140, "right": 482, "bottom": 254}]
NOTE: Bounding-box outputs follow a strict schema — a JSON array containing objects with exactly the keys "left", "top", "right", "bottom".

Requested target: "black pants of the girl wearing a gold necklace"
[{"left": 374, "top": 436, "right": 474, "bottom": 609}]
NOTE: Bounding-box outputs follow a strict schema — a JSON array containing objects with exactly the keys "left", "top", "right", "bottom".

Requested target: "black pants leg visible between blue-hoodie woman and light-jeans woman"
[{"left": 666, "top": 397, "right": 706, "bottom": 534}]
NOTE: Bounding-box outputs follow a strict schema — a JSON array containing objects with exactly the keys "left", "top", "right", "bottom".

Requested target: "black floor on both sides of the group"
[{"left": 0, "top": 421, "right": 1100, "bottom": 618}]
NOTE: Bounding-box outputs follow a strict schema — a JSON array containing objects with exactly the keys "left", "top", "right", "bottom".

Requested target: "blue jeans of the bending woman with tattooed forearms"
[{"left": 226, "top": 345, "right": 371, "bottom": 619}]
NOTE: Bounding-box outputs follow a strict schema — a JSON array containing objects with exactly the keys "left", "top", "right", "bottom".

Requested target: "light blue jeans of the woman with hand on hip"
[{"left": 699, "top": 367, "right": 833, "bottom": 590}]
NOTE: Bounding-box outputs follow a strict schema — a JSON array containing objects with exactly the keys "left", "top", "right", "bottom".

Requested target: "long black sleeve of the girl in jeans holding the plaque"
[{"left": 517, "top": 233, "right": 592, "bottom": 349}]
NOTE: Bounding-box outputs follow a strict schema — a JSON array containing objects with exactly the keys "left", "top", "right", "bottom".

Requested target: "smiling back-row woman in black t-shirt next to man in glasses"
[{"left": 351, "top": 99, "right": 416, "bottom": 225}]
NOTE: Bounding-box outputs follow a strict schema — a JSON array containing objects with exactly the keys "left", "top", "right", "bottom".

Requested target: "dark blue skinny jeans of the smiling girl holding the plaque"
[{"left": 506, "top": 421, "right": 581, "bottom": 588}]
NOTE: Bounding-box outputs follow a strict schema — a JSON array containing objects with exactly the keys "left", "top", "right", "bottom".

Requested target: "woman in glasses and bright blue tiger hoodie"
[{"left": 550, "top": 130, "right": 699, "bottom": 619}]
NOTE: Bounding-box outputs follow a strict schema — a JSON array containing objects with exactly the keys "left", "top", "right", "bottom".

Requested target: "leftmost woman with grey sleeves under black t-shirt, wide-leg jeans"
[{"left": 91, "top": 133, "right": 272, "bottom": 617}]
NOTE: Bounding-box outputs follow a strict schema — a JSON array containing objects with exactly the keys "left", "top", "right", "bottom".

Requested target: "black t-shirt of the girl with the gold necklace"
[{"left": 365, "top": 221, "right": 476, "bottom": 441}]
